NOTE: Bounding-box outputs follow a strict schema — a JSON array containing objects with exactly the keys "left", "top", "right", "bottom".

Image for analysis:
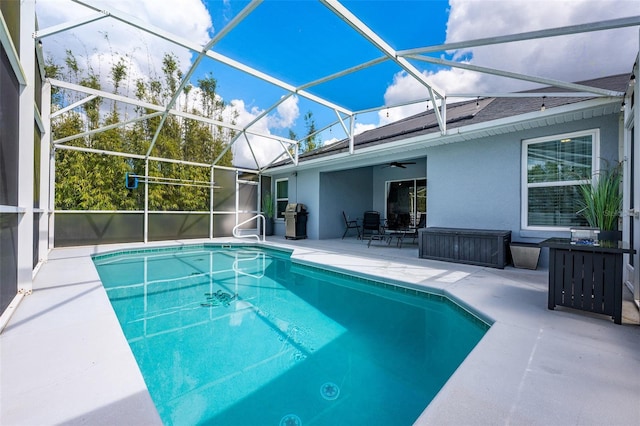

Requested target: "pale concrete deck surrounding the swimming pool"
[{"left": 0, "top": 237, "right": 640, "bottom": 426}]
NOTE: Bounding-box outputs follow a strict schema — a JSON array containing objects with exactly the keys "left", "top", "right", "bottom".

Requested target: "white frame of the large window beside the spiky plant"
[{"left": 520, "top": 129, "right": 600, "bottom": 231}]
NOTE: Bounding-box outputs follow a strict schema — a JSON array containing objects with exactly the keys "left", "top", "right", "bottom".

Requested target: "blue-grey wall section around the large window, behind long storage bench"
[{"left": 427, "top": 114, "right": 619, "bottom": 265}]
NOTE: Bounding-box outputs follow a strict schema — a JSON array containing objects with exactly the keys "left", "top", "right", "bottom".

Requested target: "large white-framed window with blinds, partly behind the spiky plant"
[{"left": 522, "top": 130, "right": 599, "bottom": 230}]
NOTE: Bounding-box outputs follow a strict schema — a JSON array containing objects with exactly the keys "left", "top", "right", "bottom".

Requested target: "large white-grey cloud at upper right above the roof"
[{"left": 379, "top": 0, "right": 638, "bottom": 124}]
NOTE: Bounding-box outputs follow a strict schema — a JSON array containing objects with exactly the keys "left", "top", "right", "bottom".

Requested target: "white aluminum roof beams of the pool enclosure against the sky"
[{"left": 34, "top": 0, "right": 640, "bottom": 171}]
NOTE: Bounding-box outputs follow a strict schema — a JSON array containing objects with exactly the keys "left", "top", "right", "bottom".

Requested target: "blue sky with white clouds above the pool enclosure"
[{"left": 36, "top": 0, "right": 640, "bottom": 167}]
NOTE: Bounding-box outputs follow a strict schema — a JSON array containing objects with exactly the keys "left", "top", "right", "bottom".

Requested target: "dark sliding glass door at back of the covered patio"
[{"left": 385, "top": 179, "right": 427, "bottom": 228}]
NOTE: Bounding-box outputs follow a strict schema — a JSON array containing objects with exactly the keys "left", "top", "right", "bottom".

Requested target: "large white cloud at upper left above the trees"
[{"left": 36, "top": 0, "right": 213, "bottom": 90}]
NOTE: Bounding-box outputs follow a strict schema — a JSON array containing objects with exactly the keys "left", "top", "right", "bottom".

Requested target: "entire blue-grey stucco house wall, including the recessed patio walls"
[{"left": 264, "top": 111, "right": 619, "bottom": 265}]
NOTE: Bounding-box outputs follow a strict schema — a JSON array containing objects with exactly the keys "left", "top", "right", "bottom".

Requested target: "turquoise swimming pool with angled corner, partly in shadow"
[{"left": 94, "top": 244, "right": 489, "bottom": 426}]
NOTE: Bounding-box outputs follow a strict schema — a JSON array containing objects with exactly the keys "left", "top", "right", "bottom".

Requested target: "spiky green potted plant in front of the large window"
[{"left": 578, "top": 163, "right": 622, "bottom": 240}]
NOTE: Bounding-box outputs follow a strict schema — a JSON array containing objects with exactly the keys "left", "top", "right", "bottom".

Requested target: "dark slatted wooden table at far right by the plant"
[{"left": 540, "top": 238, "right": 635, "bottom": 324}]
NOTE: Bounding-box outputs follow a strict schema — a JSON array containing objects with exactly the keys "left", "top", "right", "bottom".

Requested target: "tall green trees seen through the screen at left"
[{"left": 45, "top": 47, "right": 237, "bottom": 210}]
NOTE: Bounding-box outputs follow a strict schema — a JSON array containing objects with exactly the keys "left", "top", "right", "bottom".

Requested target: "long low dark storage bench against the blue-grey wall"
[{"left": 418, "top": 228, "right": 511, "bottom": 269}]
